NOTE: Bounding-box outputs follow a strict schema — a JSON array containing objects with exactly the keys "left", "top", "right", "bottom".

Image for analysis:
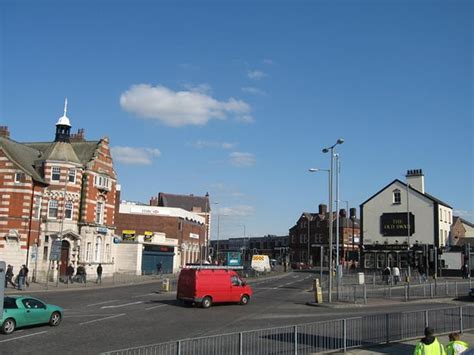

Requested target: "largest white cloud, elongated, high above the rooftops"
[{"left": 120, "top": 84, "right": 250, "bottom": 127}]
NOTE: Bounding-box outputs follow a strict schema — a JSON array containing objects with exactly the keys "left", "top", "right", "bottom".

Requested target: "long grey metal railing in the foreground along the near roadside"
[{"left": 104, "top": 306, "right": 474, "bottom": 355}]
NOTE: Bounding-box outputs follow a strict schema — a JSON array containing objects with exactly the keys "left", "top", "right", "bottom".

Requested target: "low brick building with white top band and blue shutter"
[{"left": 115, "top": 197, "right": 206, "bottom": 274}]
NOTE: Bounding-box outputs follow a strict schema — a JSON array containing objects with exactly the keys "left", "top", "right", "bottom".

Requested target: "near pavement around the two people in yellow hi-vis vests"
[{"left": 336, "top": 331, "right": 474, "bottom": 355}]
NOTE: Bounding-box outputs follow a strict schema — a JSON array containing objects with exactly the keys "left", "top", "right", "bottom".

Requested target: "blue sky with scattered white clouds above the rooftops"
[{"left": 0, "top": 0, "right": 474, "bottom": 238}]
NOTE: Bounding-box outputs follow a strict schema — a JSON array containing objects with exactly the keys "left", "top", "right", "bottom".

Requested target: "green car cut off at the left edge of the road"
[{"left": 0, "top": 296, "right": 63, "bottom": 334}]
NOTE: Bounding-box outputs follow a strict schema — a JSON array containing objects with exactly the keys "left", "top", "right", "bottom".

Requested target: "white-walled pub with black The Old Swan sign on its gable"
[{"left": 360, "top": 169, "right": 453, "bottom": 269}]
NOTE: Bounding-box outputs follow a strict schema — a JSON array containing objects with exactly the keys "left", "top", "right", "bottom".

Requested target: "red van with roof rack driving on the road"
[{"left": 176, "top": 266, "right": 253, "bottom": 308}]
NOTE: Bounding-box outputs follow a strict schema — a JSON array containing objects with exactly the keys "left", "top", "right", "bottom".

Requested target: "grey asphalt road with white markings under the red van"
[{"left": 0, "top": 272, "right": 468, "bottom": 355}]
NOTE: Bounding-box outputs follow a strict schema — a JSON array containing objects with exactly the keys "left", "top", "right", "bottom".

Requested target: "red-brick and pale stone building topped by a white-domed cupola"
[{"left": 0, "top": 102, "right": 117, "bottom": 280}]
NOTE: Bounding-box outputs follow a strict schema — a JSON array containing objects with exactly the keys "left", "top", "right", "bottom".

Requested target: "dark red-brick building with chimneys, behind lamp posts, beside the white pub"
[{"left": 289, "top": 204, "right": 360, "bottom": 265}]
